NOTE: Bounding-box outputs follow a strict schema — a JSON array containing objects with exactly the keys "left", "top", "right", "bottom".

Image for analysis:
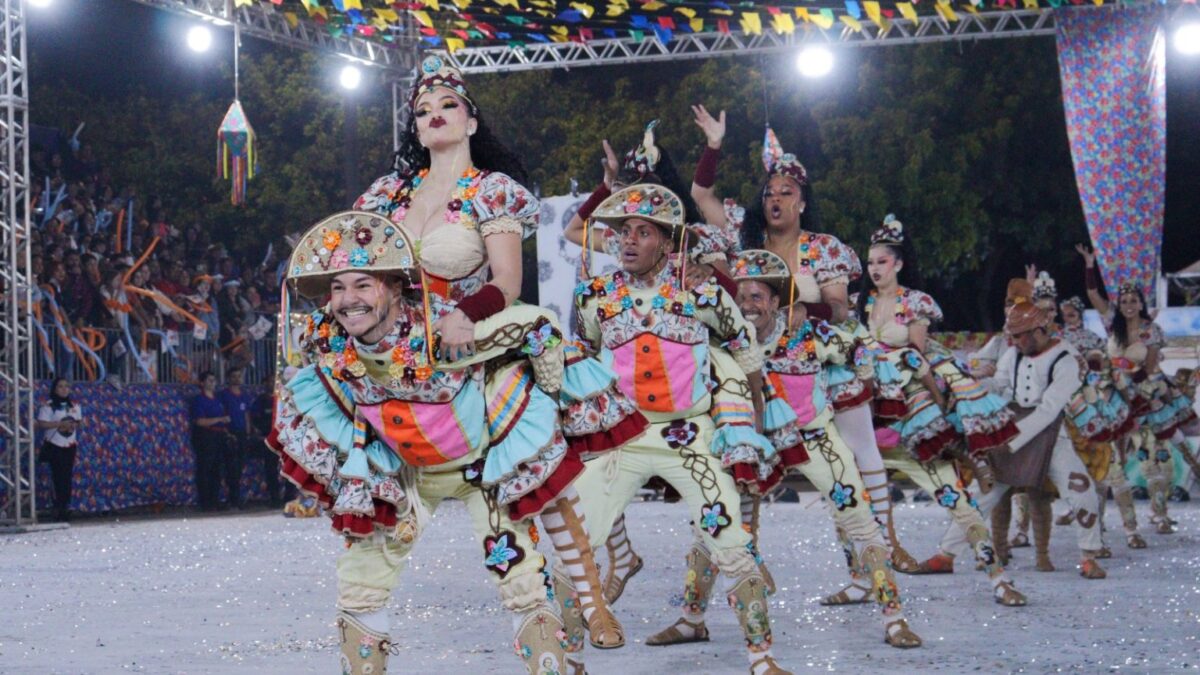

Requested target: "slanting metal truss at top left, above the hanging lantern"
[{"left": 133, "top": 0, "right": 420, "bottom": 76}]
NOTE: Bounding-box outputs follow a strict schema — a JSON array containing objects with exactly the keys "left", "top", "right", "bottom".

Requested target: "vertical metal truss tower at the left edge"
[{"left": 0, "top": 0, "right": 37, "bottom": 526}]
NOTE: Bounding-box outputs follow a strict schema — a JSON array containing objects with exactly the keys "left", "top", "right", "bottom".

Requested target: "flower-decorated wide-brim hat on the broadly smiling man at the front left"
[{"left": 288, "top": 211, "right": 418, "bottom": 298}]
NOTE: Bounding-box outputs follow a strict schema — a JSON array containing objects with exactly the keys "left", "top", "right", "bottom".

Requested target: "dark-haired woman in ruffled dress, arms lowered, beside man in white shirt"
[{"left": 856, "top": 216, "right": 1027, "bottom": 607}]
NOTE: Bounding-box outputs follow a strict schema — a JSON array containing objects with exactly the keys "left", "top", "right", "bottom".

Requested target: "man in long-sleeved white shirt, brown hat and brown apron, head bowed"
[{"left": 942, "top": 299, "right": 1106, "bottom": 579}]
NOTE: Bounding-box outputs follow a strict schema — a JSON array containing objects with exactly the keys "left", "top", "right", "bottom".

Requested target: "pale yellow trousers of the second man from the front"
[{"left": 575, "top": 414, "right": 756, "bottom": 571}]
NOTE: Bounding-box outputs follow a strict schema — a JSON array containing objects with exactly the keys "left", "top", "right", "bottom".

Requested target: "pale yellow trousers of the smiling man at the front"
[{"left": 337, "top": 458, "right": 552, "bottom": 613}]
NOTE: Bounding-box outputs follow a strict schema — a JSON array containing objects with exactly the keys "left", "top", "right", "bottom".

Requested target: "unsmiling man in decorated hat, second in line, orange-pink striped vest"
[{"left": 576, "top": 184, "right": 786, "bottom": 675}]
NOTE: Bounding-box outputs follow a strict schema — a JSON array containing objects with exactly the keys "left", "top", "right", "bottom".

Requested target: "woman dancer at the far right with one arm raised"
[{"left": 1075, "top": 245, "right": 1196, "bottom": 534}]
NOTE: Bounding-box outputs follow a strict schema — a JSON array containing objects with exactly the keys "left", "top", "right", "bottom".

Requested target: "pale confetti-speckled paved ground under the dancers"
[{"left": 0, "top": 495, "right": 1200, "bottom": 675}]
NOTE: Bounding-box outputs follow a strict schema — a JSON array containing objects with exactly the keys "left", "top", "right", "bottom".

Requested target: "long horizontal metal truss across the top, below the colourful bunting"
[{"left": 451, "top": 10, "right": 1055, "bottom": 73}]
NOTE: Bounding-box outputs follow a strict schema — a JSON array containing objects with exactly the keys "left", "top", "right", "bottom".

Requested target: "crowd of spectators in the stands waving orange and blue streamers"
[{"left": 29, "top": 124, "right": 285, "bottom": 380}]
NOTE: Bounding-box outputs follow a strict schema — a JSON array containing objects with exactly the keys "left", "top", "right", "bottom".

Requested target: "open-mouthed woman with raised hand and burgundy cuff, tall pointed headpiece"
[{"left": 691, "top": 106, "right": 918, "bottom": 566}]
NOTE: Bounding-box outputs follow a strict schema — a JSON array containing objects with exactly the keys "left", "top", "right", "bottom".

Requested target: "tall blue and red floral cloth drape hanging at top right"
[{"left": 1055, "top": 5, "right": 1166, "bottom": 298}]
